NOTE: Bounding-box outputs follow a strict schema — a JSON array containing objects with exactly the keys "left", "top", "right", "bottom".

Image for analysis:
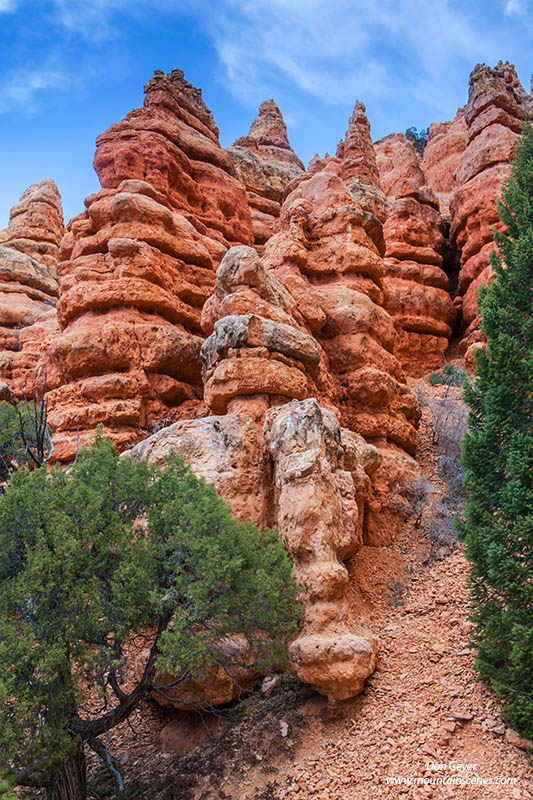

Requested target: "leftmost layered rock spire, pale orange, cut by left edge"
[{"left": 0, "top": 180, "right": 63, "bottom": 399}]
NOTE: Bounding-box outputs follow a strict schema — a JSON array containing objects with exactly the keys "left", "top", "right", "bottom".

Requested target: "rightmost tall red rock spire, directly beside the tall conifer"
[{"left": 451, "top": 61, "right": 533, "bottom": 360}]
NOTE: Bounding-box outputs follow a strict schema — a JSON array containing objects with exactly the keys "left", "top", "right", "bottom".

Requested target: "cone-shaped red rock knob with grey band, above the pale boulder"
[{"left": 198, "top": 247, "right": 327, "bottom": 418}]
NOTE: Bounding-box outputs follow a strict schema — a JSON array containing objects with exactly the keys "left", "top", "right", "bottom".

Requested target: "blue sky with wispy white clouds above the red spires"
[{"left": 0, "top": 0, "right": 533, "bottom": 228}]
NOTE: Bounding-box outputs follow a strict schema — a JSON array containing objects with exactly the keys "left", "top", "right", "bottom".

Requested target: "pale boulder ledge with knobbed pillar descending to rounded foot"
[{"left": 125, "top": 398, "right": 381, "bottom": 707}]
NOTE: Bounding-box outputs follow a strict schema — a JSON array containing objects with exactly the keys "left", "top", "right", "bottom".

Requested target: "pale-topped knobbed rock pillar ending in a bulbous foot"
[{"left": 265, "top": 399, "right": 379, "bottom": 700}]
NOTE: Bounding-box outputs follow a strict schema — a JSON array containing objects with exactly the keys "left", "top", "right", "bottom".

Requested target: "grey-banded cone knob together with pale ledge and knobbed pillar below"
[{"left": 126, "top": 241, "right": 381, "bottom": 700}]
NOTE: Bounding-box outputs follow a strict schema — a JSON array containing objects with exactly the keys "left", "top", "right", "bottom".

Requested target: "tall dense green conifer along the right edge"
[{"left": 462, "top": 124, "right": 533, "bottom": 738}]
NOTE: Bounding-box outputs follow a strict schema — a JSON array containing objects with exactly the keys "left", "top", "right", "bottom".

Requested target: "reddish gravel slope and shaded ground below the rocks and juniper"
[{"left": 78, "top": 376, "right": 533, "bottom": 800}]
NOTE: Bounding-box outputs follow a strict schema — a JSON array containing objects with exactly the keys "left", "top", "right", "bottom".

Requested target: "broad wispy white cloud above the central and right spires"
[{"left": 186, "top": 0, "right": 498, "bottom": 110}]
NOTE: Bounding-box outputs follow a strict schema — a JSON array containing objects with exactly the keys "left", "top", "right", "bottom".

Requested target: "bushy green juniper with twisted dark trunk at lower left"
[{"left": 0, "top": 438, "right": 298, "bottom": 800}]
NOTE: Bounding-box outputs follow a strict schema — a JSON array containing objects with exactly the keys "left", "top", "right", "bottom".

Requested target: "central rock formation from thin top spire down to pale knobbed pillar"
[{"left": 118, "top": 95, "right": 419, "bottom": 699}]
